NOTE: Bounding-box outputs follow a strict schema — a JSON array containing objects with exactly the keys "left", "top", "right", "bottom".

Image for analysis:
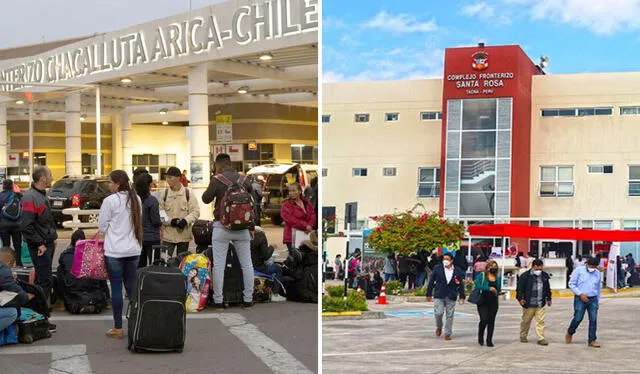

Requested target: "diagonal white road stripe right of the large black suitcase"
[{"left": 218, "top": 313, "right": 312, "bottom": 374}]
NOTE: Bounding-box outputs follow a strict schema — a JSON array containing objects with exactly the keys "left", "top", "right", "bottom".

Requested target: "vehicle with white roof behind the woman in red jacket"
[{"left": 247, "top": 164, "right": 318, "bottom": 225}]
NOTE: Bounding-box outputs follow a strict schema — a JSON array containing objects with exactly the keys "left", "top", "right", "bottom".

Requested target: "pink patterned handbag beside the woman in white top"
[{"left": 71, "top": 233, "right": 109, "bottom": 280}]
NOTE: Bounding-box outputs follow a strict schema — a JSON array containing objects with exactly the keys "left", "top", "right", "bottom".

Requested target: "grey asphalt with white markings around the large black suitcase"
[{"left": 0, "top": 302, "right": 318, "bottom": 374}]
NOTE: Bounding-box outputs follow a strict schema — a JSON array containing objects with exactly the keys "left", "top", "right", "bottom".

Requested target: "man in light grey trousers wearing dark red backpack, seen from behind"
[{"left": 202, "top": 153, "right": 254, "bottom": 311}]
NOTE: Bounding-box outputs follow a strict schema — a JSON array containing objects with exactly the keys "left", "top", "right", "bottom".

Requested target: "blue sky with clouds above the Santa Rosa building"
[{"left": 322, "top": 0, "right": 640, "bottom": 82}]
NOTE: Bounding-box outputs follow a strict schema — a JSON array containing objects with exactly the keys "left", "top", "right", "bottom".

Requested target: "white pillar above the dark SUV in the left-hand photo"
[{"left": 64, "top": 92, "right": 82, "bottom": 175}]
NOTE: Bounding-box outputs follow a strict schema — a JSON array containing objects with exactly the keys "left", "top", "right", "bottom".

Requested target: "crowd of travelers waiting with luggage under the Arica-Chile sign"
[{"left": 0, "top": 154, "right": 318, "bottom": 339}]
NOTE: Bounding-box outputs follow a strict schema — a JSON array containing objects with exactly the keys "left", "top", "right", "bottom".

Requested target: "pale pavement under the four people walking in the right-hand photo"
[{"left": 322, "top": 298, "right": 640, "bottom": 374}]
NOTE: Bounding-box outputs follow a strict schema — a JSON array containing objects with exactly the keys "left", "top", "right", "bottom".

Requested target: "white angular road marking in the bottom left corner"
[{"left": 0, "top": 344, "right": 93, "bottom": 374}]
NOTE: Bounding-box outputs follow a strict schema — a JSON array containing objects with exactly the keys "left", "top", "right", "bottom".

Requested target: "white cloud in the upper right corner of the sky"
[{"left": 503, "top": 0, "right": 640, "bottom": 35}]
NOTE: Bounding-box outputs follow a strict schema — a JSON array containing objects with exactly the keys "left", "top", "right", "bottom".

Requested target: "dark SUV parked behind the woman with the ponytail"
[{"left": 47, "top": 175, "right": 111, "bottom": 226}]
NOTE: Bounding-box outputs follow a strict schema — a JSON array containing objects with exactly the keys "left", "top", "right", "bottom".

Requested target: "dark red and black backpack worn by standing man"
[{"left": 215, "top": 174, "right": 255, "bottom": 230}]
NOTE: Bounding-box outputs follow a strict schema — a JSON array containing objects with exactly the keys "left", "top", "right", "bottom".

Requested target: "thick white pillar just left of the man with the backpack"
[{"left": 188, "top": 63, "right": 213, "bottom": 219}]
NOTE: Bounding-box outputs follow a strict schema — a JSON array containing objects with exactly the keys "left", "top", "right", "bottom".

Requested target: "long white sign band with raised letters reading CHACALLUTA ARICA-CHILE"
[{"left": 0, "top": 0, "right": 319, "bottom": 91}]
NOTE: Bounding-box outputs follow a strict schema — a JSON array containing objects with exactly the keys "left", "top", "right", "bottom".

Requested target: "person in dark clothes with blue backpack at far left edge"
[{"left": 0, "top": 179, "right": 22, "bottom": 267}]
